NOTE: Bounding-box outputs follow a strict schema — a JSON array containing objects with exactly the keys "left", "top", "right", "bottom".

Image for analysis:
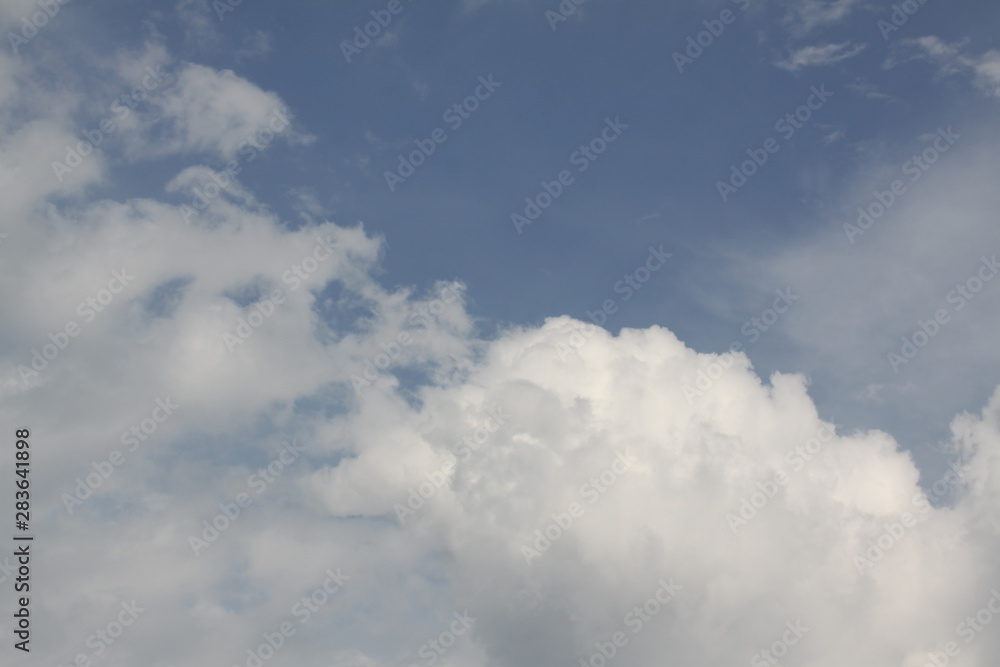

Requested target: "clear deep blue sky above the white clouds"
[{"left": 41, "top": 2, "right": 998, "bottom": 460}]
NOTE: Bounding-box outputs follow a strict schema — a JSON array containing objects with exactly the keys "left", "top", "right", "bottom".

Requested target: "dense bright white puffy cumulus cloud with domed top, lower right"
[{"left": 316, "top": 318, "right": 1000, "bottom": 665}]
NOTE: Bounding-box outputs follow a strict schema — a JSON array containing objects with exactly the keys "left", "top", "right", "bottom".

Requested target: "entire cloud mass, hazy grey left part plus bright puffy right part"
[{"left": 0, "top": 26, "right": 1000, "bottom": 667}]
